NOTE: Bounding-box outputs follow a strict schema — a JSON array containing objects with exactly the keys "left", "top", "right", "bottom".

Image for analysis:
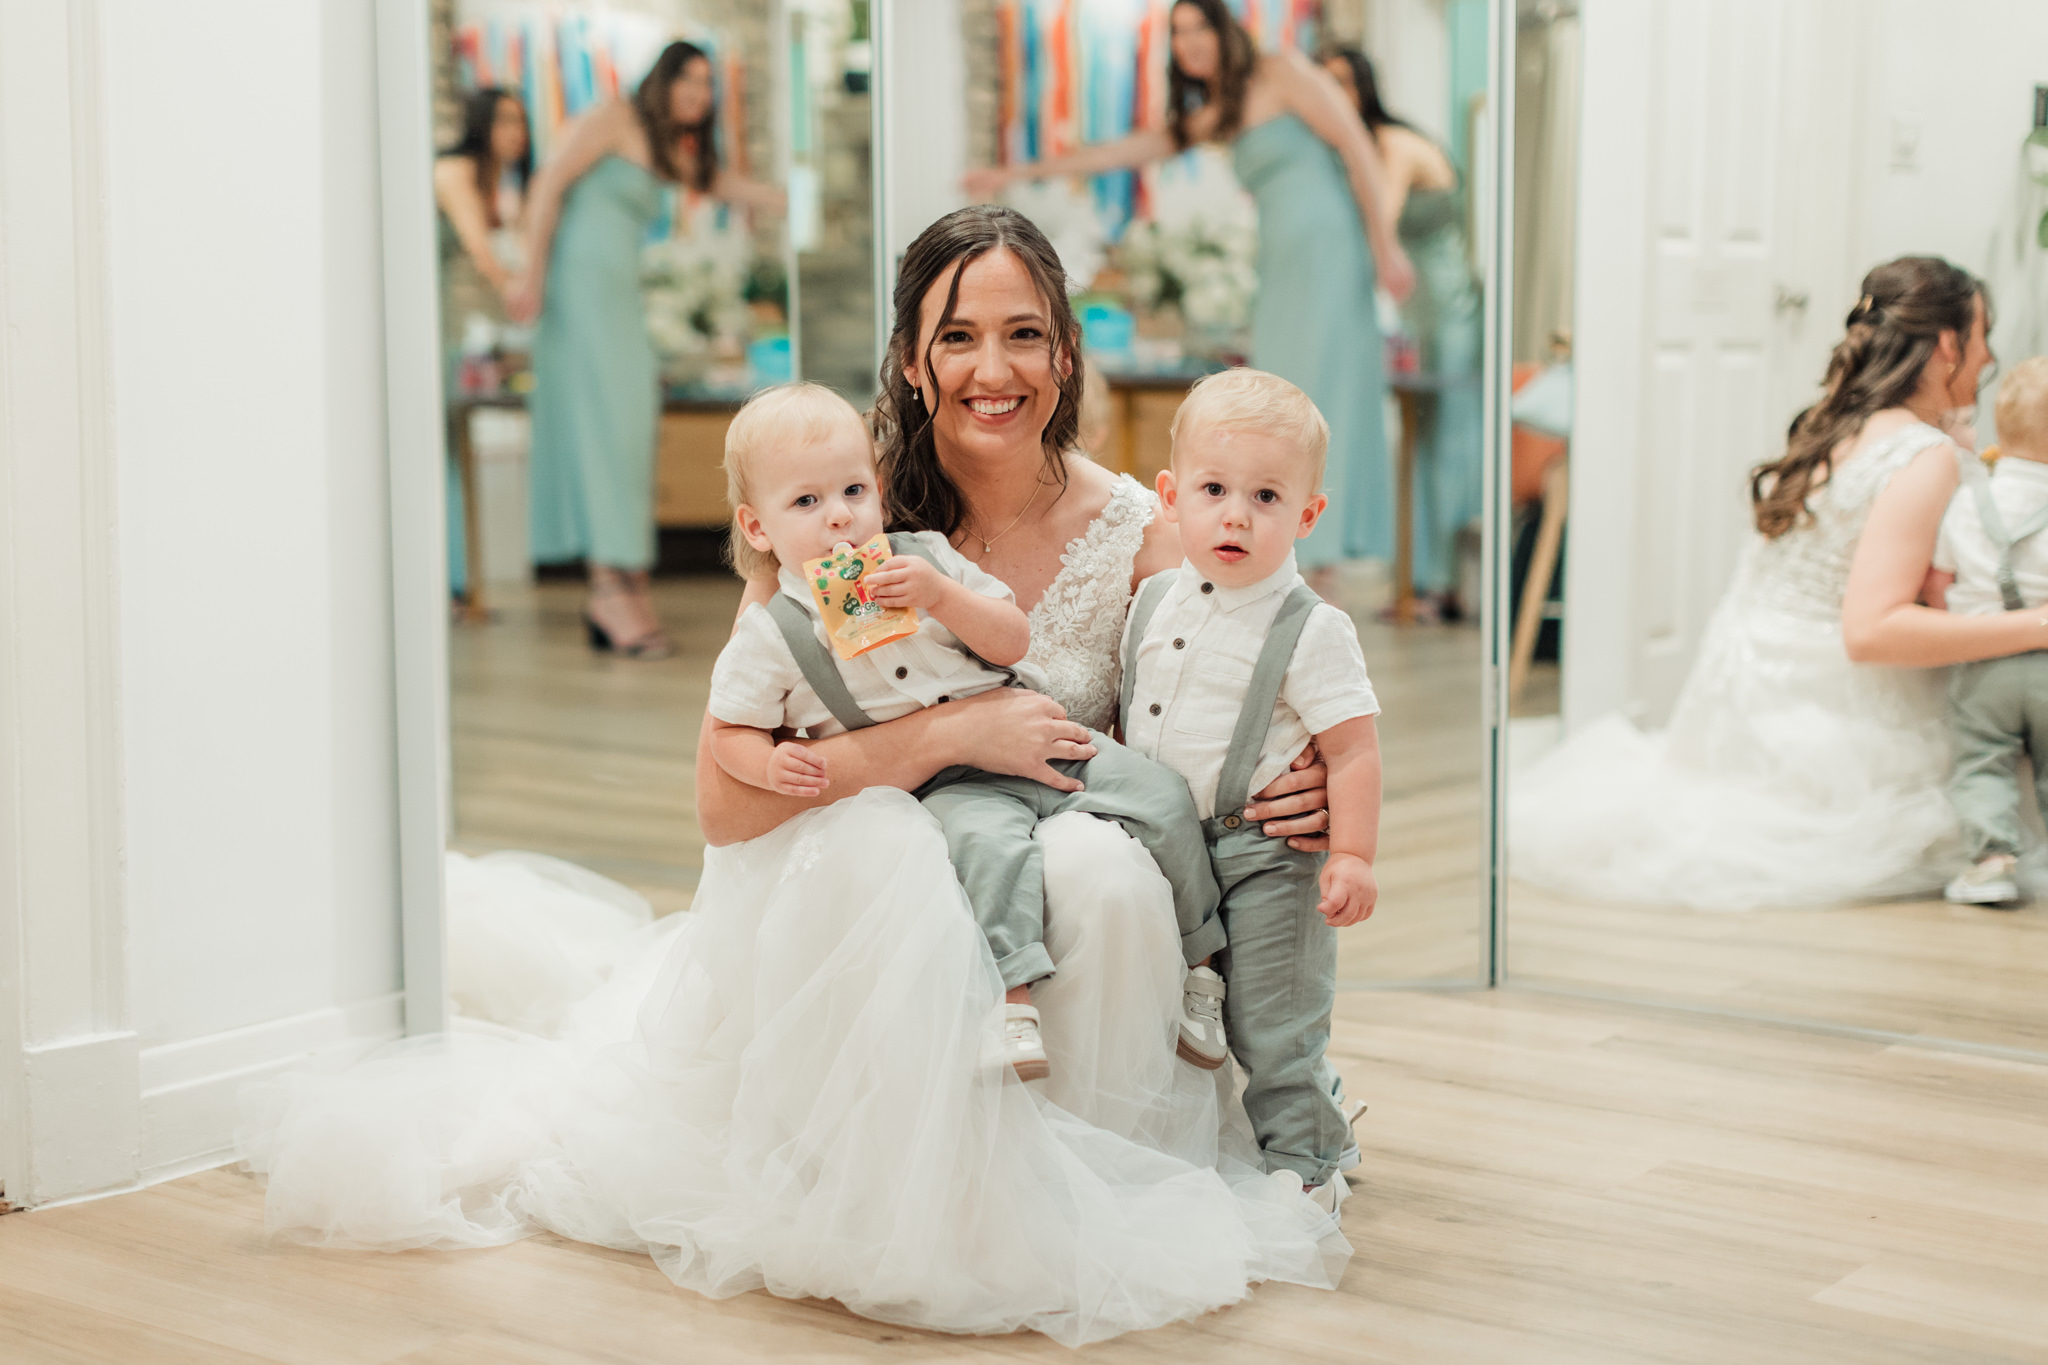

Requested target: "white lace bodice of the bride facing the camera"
[{"left": 1028, "top": 475, "right": 1159, "bottom": 731}]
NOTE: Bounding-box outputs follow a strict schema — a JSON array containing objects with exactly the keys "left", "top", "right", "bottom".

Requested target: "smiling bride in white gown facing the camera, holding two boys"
[{"left": 242, "top": 207, "right": 1350, "bottom": 1345}]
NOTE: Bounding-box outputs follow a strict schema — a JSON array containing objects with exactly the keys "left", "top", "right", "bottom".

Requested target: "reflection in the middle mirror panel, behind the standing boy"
[{"left": 963, "top": 0, "right": 1489, "bottom": 984}]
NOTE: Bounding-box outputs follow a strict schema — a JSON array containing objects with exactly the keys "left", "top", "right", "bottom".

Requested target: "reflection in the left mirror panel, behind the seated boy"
[{"left": 444, "top": 0, "right": 811, "bottom": 916}]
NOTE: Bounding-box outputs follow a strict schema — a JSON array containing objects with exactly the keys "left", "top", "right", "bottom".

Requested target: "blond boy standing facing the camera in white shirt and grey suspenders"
[{"left": 1122, "top": 370, "right": 1380, "bottom": 1214}]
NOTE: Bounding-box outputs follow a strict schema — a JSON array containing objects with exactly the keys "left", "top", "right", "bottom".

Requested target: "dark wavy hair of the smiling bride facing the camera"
[{"left": 874, "top": 205, "right": 1085, "bottom": 538}]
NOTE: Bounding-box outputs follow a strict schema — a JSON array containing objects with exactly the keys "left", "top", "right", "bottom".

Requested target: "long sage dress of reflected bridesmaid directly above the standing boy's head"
[{"left": 1231, "top": 115, "right": 1395, "bottom": 569}]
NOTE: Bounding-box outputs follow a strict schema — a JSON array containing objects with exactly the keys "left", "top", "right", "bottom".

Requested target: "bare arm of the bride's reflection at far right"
[{"left": 1841, "top": 446, "right": 2048, "bottom": 669}]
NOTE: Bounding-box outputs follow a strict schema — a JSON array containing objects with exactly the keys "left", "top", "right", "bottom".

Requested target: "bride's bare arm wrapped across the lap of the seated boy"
[{"left": 696, "top": 583, "right": 1096, "bottom": 845}]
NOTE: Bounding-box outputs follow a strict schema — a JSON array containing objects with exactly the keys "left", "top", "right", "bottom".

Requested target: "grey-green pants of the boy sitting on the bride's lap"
[{"left": 915, "top": 731, "right": 1225, "bottom": 986}]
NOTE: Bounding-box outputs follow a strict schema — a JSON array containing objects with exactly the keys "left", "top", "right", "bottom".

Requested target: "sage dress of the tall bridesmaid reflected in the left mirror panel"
[{"left": 528, "top": 156, "right": 662, "bottom": 569}]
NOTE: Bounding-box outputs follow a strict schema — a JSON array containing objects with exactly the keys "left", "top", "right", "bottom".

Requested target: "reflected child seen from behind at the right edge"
[{"left": 1933, "top": 356, "right": 2048, "bottom": 905}]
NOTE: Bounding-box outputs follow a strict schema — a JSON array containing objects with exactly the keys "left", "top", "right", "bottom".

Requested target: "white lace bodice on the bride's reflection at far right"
[{"left": 1735, "top": 422, "right": 1948, "bottom": 620}]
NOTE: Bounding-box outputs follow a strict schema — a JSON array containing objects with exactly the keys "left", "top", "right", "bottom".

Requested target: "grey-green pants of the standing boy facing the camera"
[{"left": 1204, "top": 819, "right": 1352, "bottom": 1185}]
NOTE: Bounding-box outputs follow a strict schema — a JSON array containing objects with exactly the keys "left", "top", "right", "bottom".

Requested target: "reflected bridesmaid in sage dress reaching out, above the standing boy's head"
[{"left": 967, "top": 0, "right": 1415, "bottom": 598}]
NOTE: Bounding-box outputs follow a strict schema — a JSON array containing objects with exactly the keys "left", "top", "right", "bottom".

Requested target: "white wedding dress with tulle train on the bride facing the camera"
[{"left": 242, "top": 479, "right": 1350, "bottom": 1345}]
